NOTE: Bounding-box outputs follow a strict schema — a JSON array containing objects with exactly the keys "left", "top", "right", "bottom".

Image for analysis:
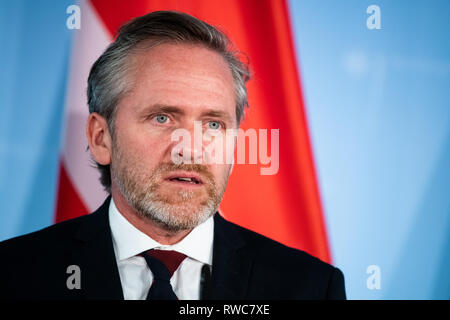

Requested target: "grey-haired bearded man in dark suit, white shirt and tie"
[{"left": 0, "top": 11, "right": 345, "bottom": 300}]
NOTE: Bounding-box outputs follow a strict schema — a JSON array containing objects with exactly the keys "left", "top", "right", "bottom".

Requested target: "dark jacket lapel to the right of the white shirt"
[{"left": 211, "top": 214, "right": 252, "bottom": 299}]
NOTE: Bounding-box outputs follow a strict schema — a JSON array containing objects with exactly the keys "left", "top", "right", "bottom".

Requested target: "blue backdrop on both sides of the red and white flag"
[{"left": 0, "top": 0, "right": 450, "bottom": 299}]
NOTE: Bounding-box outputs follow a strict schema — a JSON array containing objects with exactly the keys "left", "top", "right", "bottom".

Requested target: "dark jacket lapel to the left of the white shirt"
[{"left": 72, "top": 197, "right": 123, "bottom": 300}]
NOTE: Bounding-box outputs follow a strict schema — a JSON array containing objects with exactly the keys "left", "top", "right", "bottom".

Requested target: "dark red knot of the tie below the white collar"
[{"left": 143, "top": 249, "right": 186, "bottom": 279}]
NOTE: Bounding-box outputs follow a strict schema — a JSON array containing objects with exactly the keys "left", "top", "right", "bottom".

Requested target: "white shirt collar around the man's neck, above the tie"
[{"left": 109, "top": 198, "right": 214, "bottom": 265}]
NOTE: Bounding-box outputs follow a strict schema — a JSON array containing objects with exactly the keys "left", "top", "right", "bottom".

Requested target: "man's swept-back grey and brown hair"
[{"left": 87, "top": 11, "right": 250, "bottom": 192}]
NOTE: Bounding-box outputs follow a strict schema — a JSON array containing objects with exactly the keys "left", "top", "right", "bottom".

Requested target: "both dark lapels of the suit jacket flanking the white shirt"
[{"left": 72, "top": 197, "right": 252, "bottom": 300}]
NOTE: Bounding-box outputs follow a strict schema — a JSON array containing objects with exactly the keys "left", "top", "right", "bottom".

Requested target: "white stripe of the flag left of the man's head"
[{"left": 62, "top": 1, "right": 111, "bottom": 211}]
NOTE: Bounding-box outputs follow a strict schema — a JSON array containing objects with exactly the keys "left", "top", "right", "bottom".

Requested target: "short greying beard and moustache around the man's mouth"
[{"left": 111, "top": 142, "right": 229, "bottom": 232}]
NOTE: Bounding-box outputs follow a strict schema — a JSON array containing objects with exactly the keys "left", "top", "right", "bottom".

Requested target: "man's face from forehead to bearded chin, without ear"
[{"left": 111, "top": 44, "right": 236, "bottom": 230}]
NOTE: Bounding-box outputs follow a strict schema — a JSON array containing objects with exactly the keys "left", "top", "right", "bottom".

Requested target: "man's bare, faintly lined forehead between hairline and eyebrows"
[{"left": 121, "top": 44, "right": 236, "bottom": 122}]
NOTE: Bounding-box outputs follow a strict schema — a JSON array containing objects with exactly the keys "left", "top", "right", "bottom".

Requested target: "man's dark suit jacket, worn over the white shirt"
[{"left": 0, "top": 198, "right": 346, "bottom": 299}]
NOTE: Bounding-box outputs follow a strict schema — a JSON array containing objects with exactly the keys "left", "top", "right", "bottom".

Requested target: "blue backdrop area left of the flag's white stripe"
[{"left": 0, "top": 0, "right": 73, "bottom": 240}]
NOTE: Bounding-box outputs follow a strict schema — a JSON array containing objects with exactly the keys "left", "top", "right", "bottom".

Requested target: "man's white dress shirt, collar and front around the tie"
[{"left": 109, "top": 199, "right": 214, "bottom": 300}]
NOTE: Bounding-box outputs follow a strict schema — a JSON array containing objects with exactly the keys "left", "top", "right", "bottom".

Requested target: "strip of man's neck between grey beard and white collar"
[{"left": 111, "top": 188, "right": 192, "bottom": 245}]
